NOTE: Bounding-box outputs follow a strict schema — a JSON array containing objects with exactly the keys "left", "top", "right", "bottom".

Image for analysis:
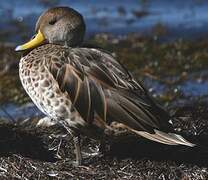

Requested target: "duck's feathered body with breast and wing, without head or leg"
[{"left": 20, "top": 44, "right": 193, "bottom": 144}]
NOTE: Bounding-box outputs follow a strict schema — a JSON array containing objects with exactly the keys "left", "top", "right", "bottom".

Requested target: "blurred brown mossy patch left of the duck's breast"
[{"left": 0, "top": 45, "right": 28, "bottom": 104}]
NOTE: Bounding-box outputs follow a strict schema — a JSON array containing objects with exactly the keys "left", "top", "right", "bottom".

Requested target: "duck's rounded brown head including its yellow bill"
[{"left": 16, "top": 7, "right": 85, "bottom": 51}]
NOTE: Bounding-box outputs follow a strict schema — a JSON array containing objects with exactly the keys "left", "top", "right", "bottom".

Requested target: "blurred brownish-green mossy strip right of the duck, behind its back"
[{"left": 90, "top": 34, "right": 208, "bottom": 77}]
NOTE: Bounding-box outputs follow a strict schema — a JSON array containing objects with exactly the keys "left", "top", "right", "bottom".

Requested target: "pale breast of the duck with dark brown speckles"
[{"left": 19, "top": 54, "right": 71, "bottom": 119}]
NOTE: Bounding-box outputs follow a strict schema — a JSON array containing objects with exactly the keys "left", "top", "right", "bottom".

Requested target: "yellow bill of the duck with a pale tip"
[{"left": 15, "top": 30, "right": 45, "bottom": 51}]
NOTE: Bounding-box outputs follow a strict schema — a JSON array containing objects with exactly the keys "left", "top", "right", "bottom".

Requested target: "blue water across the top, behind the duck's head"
[{"left": 0, "top": 0, "right": 208, "bottom": 43}]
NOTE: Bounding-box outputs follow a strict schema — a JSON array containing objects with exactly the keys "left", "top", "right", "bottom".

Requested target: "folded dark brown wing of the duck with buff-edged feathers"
[{"left": 47, "top": 48, "right": 174, "bottom": 133}]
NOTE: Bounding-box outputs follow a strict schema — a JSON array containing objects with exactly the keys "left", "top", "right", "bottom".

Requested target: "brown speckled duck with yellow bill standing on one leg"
[{"left": 15, "top": 7, "right": 195, "bottom": 166}]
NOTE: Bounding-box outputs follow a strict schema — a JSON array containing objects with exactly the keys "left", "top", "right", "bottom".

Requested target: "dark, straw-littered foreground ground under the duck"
[{"left": 0, "top": 103, "right": 208, "bottom": 180}]
